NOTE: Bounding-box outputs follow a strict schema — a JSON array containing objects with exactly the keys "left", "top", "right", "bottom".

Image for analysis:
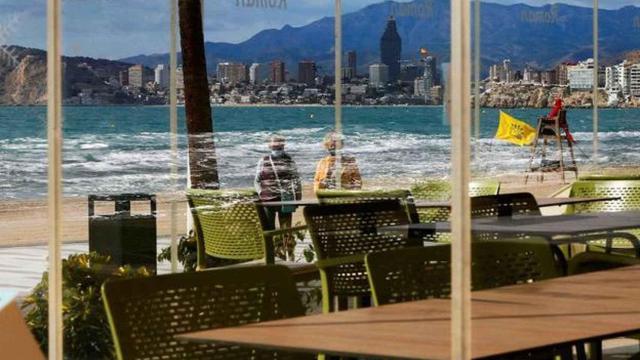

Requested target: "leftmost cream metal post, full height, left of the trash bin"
[{"left": 47, "top": 0, "right": 63, "bottom": 360}]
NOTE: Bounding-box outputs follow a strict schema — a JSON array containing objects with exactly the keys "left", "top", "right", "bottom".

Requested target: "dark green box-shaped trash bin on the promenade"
[{"left": 89, "top": 194, "right": 157, "bottom": 273}]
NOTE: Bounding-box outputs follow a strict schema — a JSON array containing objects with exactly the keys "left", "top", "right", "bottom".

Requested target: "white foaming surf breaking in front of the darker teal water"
[{"left": 0, "top": 121, "right": 640, "bottom": 197}]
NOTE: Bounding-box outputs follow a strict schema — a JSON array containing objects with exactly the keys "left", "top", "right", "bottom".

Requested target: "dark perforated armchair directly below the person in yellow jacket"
[{"left": 304, "top": 200, "right": 422, "bottom": 312}]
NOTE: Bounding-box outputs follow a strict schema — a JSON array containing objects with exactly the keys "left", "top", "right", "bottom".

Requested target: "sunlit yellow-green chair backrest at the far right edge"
[{"left": 567, "top": 180, "right": 640, "bottom": 214}]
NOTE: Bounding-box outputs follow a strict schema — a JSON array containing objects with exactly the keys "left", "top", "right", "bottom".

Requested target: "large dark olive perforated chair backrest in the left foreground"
[{"left": 102, "top": 265, "right": 304, "bottom": 360}]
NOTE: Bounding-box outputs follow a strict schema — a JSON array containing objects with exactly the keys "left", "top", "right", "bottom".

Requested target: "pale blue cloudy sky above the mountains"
[{"left": 0, "top": 0, "right": 640, "bottom": 59}]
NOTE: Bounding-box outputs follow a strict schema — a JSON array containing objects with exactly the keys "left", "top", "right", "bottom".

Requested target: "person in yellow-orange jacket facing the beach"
[{"left": 313, "top": 131, "right": 362, "bottom": 192}]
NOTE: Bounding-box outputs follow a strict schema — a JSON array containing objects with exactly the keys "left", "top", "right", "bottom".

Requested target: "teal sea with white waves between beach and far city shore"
[{"left": 0, "top": 106, "right": 640, "bottom": 199}]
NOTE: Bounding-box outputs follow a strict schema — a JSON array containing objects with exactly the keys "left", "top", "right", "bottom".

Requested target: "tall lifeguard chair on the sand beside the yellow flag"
[{"left": 524, "top": 110, "right": 578, "bottom": 184}]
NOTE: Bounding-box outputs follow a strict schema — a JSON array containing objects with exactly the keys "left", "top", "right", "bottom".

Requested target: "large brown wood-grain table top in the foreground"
[{"left": 180, "top": 266, "right": 640, "bottom": 359}]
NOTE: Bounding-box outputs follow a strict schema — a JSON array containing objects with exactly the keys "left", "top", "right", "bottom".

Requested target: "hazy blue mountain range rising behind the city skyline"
[{"left": 120, "top": 0, "right": 640, "bottom": 73}]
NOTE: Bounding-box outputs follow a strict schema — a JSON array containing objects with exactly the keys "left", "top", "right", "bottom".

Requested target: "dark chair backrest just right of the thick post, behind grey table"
[{"left": 471, "top": 193, "right": 541, "bottom": 217}]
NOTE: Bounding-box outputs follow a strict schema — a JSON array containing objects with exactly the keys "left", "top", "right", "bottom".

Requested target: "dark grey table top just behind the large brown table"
[{"left": 388, "top": 211, "right": 640, "bottom": 236}]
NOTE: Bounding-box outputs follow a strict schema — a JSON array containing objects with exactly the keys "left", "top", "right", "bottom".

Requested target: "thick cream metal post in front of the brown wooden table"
[{"left": 450, "top": 1, "right": 471, "bottom": 360}]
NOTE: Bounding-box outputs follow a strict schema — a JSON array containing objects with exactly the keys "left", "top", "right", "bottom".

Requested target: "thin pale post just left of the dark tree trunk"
[{"left": 169, "top": 0, "right": 178, "bottom": 273}]
